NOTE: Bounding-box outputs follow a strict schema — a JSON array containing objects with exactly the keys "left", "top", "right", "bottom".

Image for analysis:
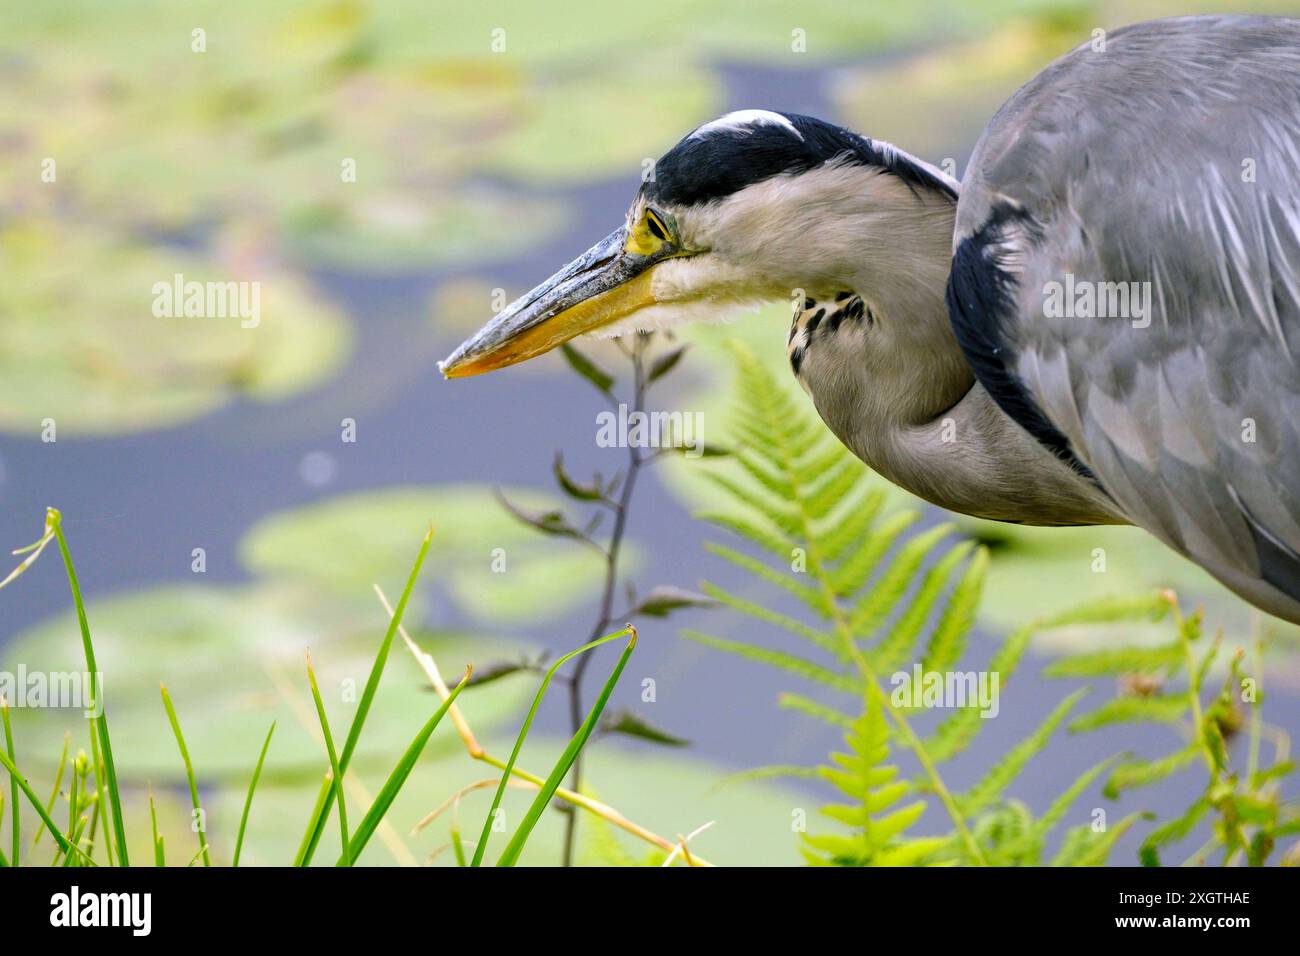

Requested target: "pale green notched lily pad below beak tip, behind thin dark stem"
[{"left": 241, "top": 485, "right": 613, "bottom": 624}]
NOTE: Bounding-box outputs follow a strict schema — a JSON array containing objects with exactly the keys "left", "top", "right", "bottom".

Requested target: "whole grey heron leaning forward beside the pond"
[{"left": 441, "top": 17, "right": 1300, "bottom": 622}]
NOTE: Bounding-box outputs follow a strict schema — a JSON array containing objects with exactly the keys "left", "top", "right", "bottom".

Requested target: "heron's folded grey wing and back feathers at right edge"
[{"left": 954, "top": 17, "right": 1300, "bottom": 620}]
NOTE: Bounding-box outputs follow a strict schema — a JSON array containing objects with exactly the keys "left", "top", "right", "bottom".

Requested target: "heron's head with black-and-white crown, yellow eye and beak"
[{"left": 439, "top": 109, "right": 956, "bottom": 378}]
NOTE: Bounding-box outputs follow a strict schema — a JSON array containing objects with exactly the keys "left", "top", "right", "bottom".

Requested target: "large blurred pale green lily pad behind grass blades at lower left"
[{"left": 4, "top": 587, "right": 538, "bottom": 786}]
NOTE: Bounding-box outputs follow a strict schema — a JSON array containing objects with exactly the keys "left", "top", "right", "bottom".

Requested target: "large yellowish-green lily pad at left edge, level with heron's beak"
[{"left": 0, "top": 220, "right": 351, "bottom": 434}]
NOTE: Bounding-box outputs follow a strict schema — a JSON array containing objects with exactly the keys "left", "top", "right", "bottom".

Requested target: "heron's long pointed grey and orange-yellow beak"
[{"left": 438, "top": 228, "right": 658, "bottom": 378}]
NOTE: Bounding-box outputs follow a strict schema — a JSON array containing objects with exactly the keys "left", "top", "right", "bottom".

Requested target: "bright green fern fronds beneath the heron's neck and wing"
[{"left": 685, "top": 347, "right": 1300, "bottom": 865}]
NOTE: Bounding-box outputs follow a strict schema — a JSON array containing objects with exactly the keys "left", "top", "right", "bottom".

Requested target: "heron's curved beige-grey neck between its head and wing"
[{"left": 800, "top": 180, "right": 1123, "bottom": 524}]
